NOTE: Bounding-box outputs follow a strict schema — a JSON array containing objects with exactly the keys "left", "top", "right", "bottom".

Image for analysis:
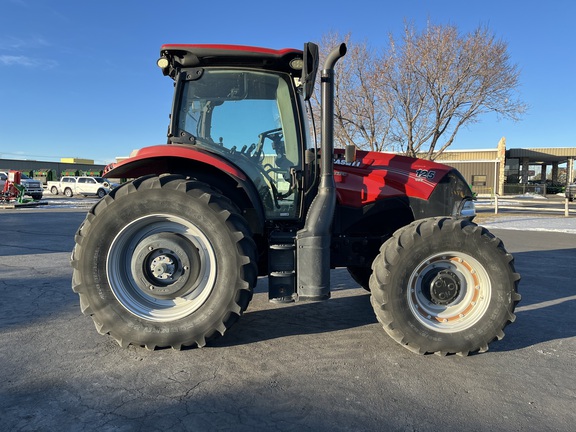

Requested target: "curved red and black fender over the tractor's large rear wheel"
[{"left": 103, "top": 144, "right": 265, "bottom": 234}]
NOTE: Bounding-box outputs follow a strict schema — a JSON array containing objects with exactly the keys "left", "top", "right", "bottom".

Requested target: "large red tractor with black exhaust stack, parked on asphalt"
[{"left": 72, "top": 43, "right": 520, "bottom": 355}]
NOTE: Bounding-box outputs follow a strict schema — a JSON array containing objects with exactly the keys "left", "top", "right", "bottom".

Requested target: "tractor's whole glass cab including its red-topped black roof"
[{"left": 158, "top": 45, "right": 318, "bottom": 220}]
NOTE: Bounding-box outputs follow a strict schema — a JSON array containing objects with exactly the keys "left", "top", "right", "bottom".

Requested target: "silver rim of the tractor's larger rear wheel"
[{"left": 106, "top": 214, "right": 217, "bottom": 322}]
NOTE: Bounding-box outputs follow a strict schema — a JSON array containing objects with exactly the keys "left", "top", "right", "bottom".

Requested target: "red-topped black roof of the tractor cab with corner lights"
[{"left": 160, "top": 44, "right": 303, "bottom": 77}]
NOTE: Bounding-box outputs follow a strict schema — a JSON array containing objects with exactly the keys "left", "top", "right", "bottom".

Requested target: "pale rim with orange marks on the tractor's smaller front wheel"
[{"left": 407, "top": 252, "right": 492, "bottom": 333}]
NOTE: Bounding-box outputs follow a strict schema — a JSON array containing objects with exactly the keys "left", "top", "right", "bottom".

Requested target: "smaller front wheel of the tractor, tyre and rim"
[{"left": 370, "top": 218, "right": 520, "bottom": 355}]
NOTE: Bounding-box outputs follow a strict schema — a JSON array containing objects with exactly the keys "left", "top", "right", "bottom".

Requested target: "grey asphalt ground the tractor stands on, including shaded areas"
[{"left": 0, "top": 201, "right": 576, "bottom": 431}]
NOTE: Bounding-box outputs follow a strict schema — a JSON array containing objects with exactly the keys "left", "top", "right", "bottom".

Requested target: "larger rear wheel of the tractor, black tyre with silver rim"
[{"left": 72, "top": 176, "right": 257, "bottom": 349}]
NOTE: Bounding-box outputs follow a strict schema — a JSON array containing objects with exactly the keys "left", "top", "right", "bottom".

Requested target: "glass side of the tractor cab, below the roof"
[{"left": 173, "top": 69, "right": 301, "bottom": 219}]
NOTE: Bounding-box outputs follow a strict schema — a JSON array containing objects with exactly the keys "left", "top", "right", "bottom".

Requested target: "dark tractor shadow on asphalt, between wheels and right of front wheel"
[{"left": 210, "top": 248, "right": 576, "bottom": 352}]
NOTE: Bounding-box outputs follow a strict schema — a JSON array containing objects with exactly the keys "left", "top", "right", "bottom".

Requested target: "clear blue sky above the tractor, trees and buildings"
[{"left": 0, "top": 0, "right": 576, "bottom": 164}]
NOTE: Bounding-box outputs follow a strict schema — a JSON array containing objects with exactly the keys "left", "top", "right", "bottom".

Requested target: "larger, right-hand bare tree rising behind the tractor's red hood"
[{"left": 377, "top": 25, "right": 526, "bottom": 159}]
